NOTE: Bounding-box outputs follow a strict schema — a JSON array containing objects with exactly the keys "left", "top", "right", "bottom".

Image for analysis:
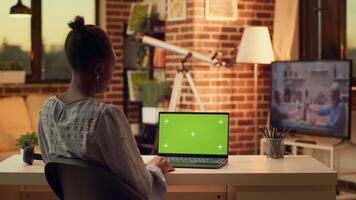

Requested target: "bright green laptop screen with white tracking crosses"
[{"left": 158, "top": 113, "right": 229, "bottom": 155}]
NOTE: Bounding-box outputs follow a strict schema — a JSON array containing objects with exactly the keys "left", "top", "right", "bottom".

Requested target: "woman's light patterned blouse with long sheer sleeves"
[{"left": 38, "top": 96, "right": 166, "bottom": 199}]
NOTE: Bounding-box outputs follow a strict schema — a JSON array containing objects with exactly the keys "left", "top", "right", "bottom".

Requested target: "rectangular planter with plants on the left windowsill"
[{"left": 0, "top": 61, "right": 26, "bottom": 83}]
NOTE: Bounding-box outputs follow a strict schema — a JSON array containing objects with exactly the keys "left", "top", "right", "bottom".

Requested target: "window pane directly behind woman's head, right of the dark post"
[{"left": 41, "top": 0, "right": 95, "bottom": 80}]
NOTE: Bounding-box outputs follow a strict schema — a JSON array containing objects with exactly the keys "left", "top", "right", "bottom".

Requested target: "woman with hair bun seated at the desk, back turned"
[{"left": 38, "top": 16, "right": 174, "bottom": 199}]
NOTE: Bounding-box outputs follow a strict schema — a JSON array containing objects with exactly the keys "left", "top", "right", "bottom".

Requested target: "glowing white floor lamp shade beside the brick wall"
[{"left": 236, "top": 26, "right": 274, "bottom": 64}]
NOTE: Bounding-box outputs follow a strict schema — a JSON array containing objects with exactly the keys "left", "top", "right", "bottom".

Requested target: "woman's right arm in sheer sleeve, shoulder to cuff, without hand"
[{"left": 95, "top": 107, "right": 166, "bottom": 199}]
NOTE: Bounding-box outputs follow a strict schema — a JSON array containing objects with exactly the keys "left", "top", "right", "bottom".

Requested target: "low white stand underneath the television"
[{"left": 260, "top": 134, "right": 346, "bottom": 170}]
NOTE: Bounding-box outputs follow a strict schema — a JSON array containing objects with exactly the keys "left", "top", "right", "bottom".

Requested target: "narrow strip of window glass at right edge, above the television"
[{"left": 346, "top": 0, "right": 356, "bottom": 79}]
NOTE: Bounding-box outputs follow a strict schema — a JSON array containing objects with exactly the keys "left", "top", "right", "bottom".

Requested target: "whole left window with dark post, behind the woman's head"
[{"left": 0, "top": 0, "right": 98, "bottom": 82}]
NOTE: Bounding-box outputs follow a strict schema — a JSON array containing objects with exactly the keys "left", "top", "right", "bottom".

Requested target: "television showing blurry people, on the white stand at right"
[{"left": 270, "top": 60, "right": 352, "bottom": 139}]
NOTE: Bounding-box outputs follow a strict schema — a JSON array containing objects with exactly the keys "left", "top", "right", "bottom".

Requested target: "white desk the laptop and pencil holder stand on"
[{"left": 0, "top": 155, "right": 337, "bottom": 200}]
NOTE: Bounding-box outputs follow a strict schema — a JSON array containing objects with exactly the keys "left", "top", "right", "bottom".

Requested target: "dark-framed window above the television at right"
[{"left": 300, "top": 0, "right": 356, "bottom": 83}]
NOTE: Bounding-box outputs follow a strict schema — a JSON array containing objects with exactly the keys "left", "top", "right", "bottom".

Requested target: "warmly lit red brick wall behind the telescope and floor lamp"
[{"left": 166, "top": 0, "right": 274, "bottom": 154}]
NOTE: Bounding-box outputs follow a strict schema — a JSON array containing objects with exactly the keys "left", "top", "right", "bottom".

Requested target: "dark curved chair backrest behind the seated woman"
[{"left": 45, "top": 158, "right": 147, "bottom": 200}]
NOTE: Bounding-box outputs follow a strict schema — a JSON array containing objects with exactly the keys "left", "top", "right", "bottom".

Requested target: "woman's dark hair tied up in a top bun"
[{"left": 65, "top": 16, "right": 112, "bottom": 72}]
